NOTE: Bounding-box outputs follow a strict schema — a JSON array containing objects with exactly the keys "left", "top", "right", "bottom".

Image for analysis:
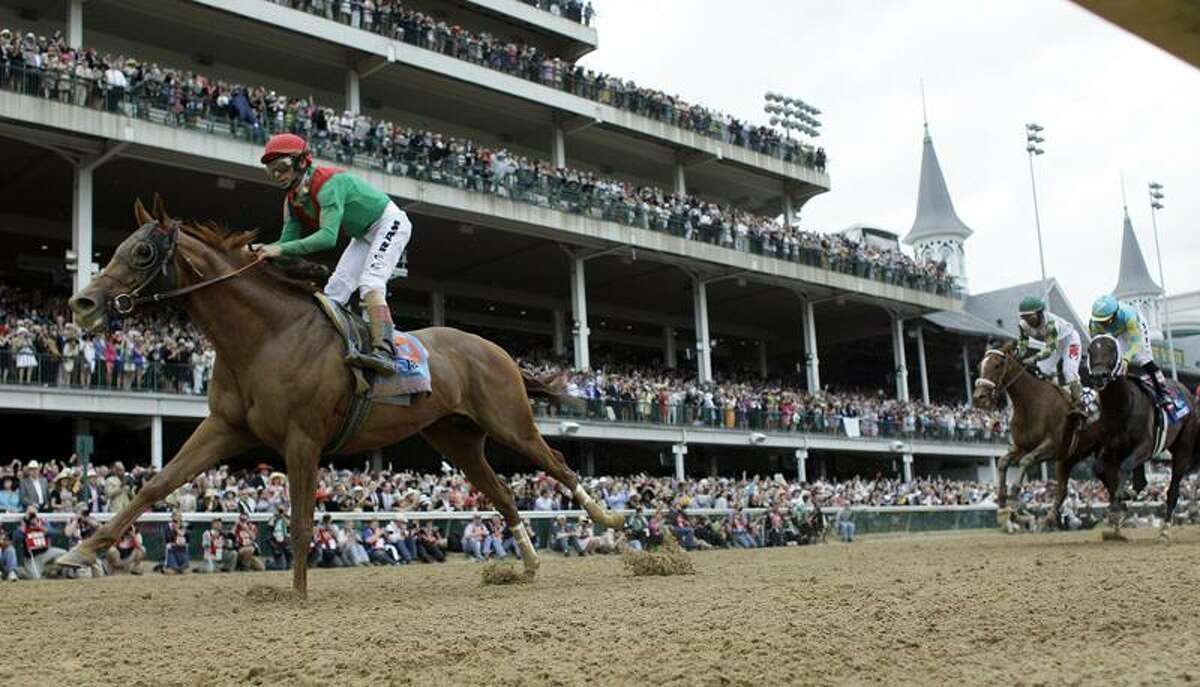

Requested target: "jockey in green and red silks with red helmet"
[{"left": 254, "top": 133, "right": 413, "bottom": 375}]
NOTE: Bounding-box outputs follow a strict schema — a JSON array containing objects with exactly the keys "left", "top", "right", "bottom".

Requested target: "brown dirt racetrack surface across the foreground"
[{"left": 7, "top": 528, "right": 1200, "bottom": 686}]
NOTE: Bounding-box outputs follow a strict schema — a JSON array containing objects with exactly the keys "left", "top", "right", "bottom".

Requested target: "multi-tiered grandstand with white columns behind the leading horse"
[{"left": 0, "top": 0, "right": 1008, "bottom": 480}]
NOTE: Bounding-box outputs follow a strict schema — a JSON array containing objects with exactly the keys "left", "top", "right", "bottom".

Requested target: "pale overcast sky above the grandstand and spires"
[{"left": 584, "top": 0, "right": 1200, "bottom": 317}]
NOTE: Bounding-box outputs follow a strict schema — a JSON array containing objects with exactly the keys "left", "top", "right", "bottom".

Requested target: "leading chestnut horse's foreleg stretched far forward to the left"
[{"left": 55, "top": 416, "right": 259, "bottom": 568}]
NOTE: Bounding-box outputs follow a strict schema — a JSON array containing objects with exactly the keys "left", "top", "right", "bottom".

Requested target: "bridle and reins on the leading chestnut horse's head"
[{"left": 109, "top": 220, "right": 263, "bottom": 315}]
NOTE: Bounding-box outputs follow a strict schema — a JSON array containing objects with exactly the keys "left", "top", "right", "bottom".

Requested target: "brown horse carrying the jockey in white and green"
[{"left": 973, "top": 344, "right": 1099, "bottom": 527}]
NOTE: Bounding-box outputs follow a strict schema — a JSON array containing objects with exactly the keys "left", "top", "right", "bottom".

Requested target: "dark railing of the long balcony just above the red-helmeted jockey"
[{"left": 0, "top": 61, "right": 960, "bottom": 297}]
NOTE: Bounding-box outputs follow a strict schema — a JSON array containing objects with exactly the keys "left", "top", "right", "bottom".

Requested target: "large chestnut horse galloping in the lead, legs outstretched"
[{"left": 58, "top": 196, "right": 624, "bottom": 597}]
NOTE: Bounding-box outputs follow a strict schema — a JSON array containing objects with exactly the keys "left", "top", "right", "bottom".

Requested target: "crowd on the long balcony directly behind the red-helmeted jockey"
[{"left": 0, "top": 22, "right": 954, "bottom": 293}]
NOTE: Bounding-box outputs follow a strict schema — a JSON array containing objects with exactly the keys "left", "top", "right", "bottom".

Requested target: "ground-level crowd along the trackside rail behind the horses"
[{"left": 0, "top": 456, "right": 1200, "bottom": 579}]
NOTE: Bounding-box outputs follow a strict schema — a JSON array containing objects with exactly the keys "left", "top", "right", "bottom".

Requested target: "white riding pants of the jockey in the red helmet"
[{"left": 325, "top": 203, "right": 413, "bottom": 305}]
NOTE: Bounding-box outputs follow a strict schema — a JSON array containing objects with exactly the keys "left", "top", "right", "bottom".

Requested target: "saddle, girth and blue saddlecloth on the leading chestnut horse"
[{"left": 313, "top": 291, "right": 432, "bottom": 455}]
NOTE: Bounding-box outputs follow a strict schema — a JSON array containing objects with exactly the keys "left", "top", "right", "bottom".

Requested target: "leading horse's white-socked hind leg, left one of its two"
[{"left": 421, "top": 417, "right": 541, "bottom": 578}]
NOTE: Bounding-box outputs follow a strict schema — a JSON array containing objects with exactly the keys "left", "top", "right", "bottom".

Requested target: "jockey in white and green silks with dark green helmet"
[{"left": 1016, "top": 295, "right": 1084, "bottom": 413}]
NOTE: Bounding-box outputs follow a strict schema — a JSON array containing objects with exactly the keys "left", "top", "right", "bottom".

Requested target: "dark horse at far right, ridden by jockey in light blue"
[{"left": 1087, "top": 334, "right": 1200, "bottom": 543}]
